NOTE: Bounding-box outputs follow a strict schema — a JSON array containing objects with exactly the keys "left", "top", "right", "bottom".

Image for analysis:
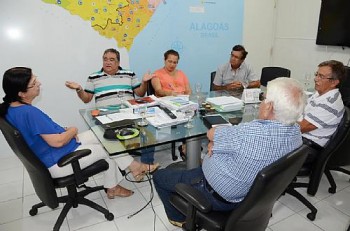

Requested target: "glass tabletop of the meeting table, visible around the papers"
[{"left": 79, "top": 91, "right": 258, "bottom": 155}]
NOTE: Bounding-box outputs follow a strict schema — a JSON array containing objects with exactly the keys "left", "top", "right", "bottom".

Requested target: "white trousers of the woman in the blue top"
[{"left": 49, "top": 130, "right": 134, "bottom": 188}]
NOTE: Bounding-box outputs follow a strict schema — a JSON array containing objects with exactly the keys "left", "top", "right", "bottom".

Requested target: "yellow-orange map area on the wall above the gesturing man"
[{"left": 42, "top": 0, "right": 164, "bottom": 50}]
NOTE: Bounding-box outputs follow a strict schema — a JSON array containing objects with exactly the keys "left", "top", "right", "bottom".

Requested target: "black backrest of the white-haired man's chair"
[{"left": 225, "top": 145, "right": 307, "bottom": 231}]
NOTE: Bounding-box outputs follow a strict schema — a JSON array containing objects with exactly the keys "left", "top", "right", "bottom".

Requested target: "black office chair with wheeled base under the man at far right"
[{"left": 286, "top": 107, "right": 350, "bottom": 221}]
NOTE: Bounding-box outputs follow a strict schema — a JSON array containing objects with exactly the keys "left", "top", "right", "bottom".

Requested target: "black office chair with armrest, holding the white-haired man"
[{"left": 170, "top": 146, "right": 307, "bottom": 231}]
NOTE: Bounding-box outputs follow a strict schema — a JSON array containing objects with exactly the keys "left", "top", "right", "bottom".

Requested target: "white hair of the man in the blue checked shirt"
[{"left": 266, "top": 77, "right": 306, "bottom": 124}]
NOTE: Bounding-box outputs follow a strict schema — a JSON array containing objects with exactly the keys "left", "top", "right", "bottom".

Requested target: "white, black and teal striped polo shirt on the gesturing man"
[{"left": 85, "top": 67, "right": 141, "bottom": 107}]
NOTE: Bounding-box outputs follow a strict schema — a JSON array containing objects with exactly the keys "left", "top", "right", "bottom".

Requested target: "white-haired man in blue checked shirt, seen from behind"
[{"left": 153, "top": 78, "right": 305, "bottom": 226}]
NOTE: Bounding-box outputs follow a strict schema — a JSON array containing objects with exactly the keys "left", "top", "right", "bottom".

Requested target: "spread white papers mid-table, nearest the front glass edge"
[{"left": 146, "top": 107, "right": 187, "bottom": 128}]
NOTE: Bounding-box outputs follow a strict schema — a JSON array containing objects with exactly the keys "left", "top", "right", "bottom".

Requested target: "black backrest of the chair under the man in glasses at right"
[{"left": 307, "top": 107, "right": 350, "bottom": 196}]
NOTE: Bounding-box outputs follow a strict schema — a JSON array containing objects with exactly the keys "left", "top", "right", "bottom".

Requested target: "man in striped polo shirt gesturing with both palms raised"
[{"left": 66, "top": 48, "right": 154, "bottom": 164}]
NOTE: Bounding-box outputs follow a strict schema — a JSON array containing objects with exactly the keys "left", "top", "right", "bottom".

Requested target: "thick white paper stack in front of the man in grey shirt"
[{"left": 207, "top": 96, "right": 243, "bottom": 112}]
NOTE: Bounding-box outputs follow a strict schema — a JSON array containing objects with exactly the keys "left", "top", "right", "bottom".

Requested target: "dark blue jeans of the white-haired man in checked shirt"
[{"left": 153, "top": 167, "right": 239, "bottom": 222}]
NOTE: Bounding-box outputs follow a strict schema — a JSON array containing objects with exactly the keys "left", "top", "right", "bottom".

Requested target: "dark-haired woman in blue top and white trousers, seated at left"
[{"left": 0, "top": 67, "right": 158, "bottom": 199}]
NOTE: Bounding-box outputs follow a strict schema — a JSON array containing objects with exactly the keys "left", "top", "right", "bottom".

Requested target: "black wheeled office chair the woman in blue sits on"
[{"left": 0, "top": 117, "right": 114, "bottom": 231}]
